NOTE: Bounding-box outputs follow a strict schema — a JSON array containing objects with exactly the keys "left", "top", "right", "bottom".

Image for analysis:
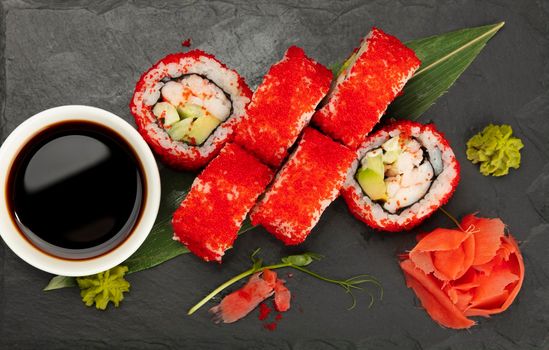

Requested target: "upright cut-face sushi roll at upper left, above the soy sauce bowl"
[{"left": 130, "top": 50, "right": 252, "bottom": 170}]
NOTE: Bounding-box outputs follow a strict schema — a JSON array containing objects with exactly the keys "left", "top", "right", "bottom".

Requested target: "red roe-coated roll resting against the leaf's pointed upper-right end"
[{"left": 313, "top": 28, "right": 421, "bottom": 149}]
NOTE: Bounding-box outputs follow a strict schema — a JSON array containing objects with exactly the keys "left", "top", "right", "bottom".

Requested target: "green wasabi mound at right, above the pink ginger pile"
[{"left": 467, "top": 124, "right": 524, "bottom": 176}]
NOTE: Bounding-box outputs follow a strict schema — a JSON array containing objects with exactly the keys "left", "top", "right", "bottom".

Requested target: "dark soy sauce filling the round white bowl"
[{"left": 6, "top": 121, "right": 146, "bottom": 259}]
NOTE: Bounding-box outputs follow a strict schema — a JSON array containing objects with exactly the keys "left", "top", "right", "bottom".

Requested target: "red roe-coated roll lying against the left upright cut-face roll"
[{"left": 235, "top": 46, "right": 332, "bottom": 167}]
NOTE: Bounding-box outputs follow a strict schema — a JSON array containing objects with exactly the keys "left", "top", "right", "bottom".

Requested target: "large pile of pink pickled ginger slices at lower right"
[{"left": 400, "top": 215, "right": 524, "bottom": 329}]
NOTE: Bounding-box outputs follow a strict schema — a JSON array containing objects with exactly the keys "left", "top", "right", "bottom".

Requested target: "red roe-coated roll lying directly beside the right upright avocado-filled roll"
[{"left": 250, "top": 128, "right": 356, "bottom": 245}]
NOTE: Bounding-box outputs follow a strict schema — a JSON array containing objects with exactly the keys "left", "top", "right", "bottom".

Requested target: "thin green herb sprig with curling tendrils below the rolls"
[{"left": 187, "top": 248, "right": 383, "bottom": 315}]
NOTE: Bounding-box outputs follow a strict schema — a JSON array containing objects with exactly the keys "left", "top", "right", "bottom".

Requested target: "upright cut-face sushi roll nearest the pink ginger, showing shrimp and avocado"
[{"left": 342, "top": 121, "right": 459, "bottom": 232}]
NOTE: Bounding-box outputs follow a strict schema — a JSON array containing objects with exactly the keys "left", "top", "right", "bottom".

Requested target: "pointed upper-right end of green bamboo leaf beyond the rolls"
[{"left": 387, "top": 22, "right": 505, "bottom": 120}]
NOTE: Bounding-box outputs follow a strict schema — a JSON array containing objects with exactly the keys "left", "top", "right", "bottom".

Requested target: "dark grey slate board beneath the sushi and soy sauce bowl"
[{"left": 0, "top": 0, "right": 549, "bottom": 349}]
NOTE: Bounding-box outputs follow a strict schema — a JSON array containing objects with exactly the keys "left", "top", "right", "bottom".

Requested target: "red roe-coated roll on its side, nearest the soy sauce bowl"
[{"left": 172, "top": 143, "right": 274, "bottom": 261}]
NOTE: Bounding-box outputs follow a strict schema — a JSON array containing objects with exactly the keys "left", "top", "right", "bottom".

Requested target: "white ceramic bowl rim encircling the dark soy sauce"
[{"left": 0, "top": 105, "right": 160, "bottom": 276}]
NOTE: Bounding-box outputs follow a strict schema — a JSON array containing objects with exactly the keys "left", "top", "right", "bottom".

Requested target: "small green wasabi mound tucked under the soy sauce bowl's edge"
[{"left": 76, "top": 266, "right": 130, "bottom": 310}]
